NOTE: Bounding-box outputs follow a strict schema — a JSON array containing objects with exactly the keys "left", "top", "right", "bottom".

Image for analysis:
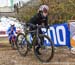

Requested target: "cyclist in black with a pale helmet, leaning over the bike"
[{"left": 29, "top": 5, "right": 49, "bottom": 55}]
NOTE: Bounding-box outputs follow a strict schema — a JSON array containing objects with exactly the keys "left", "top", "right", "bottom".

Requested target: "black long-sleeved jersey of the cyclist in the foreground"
[{"left": 29, "top": 13, "right": 48, "bottom": 26}]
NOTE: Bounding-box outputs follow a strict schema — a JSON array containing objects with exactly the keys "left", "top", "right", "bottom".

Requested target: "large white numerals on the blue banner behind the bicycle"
[{"left": 42, "top": 25, "right": 66, "bottom": 45}]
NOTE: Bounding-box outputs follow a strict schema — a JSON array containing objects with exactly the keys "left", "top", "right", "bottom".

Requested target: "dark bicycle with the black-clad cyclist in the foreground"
[{"left": 16, "top": 23, "right": 54, "bottom": 62}]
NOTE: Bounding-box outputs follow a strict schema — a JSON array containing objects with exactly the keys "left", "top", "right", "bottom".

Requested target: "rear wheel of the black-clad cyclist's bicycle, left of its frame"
[{"left": 16, "top": 33, "right": 28, "bottom": 56}]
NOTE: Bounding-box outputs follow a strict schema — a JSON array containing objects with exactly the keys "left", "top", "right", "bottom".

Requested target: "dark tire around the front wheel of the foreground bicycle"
[{"left": 33, "top": 34, "right": 54, "bottom": 62}]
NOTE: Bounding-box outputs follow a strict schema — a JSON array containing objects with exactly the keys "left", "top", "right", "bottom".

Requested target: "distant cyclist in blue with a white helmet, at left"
[{"left": 7, "top": 21, "right": 16, "bottom": 44}]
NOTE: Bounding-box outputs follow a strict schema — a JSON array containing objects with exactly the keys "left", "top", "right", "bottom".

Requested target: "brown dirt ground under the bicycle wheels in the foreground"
[{"left": 0, "top": 38, "right": 75, "bottom": 65}]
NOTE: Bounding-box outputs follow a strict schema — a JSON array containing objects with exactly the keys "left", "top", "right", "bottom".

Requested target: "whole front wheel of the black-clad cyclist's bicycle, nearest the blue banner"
[{"left": 33, "top": 34, "right": 54, "bottom": 62}]
